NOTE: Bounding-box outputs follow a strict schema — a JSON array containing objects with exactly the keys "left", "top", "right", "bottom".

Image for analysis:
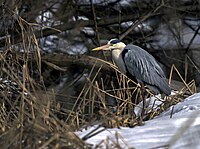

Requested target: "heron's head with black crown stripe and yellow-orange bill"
[{"left": 92, "top": 39, "right": 126, "bottom": 51}]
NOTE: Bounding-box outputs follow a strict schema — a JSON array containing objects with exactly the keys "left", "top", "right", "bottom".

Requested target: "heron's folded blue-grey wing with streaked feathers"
[{"left": 122, "top": 44, "right": 171, "bottom": 95}]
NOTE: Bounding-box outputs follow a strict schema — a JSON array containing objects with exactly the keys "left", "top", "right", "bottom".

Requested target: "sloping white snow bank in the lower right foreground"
[{"left": 76, "top": 93, "right": 200, "bottom": 149}]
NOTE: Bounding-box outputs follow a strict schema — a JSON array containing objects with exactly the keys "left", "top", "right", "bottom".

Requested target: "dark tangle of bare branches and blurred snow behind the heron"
[{"left": 0, "top": 0, "right": 200, "bottom": 85}]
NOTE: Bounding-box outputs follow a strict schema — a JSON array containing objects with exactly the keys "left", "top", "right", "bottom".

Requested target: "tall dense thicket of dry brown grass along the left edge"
[{"left": 0, "top": 18, "right": 90, "bottom": 148}]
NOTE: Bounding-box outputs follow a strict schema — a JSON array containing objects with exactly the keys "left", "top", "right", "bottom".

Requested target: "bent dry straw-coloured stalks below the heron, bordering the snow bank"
[{"left": 67, "top": 59, "right": 196, "bottom": 128}]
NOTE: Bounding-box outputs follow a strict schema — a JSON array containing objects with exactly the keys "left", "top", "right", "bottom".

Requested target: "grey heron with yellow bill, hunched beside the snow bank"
[{"left": 92, "top": 39, "right": 171, "bottom": 95}]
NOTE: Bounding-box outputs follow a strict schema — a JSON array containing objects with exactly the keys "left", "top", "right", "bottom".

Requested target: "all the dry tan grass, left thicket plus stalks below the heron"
[{"left": 0, "top": 11, "right": 195, "bottom": 148}]
